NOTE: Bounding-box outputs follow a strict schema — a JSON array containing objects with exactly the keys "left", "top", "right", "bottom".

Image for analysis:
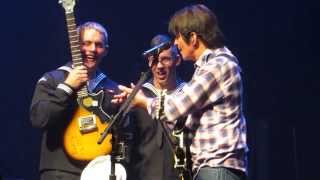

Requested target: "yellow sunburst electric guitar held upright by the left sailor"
[{"left": 59, "top": 0, "right": 112, "bottom": 161}]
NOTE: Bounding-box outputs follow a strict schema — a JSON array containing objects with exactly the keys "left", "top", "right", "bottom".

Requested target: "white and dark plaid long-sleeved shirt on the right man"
[{"left": 148, "top": 47, "right": 248, "bottom": 173}]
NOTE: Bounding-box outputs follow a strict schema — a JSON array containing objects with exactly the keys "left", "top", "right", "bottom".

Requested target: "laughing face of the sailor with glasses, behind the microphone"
[{"left": 149, "top": 48, "right": 180, "bottom": 90}]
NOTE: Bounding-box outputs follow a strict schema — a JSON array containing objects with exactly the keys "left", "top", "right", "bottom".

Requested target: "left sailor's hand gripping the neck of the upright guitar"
[{"left": 64, "top": 65, "right": 89, "bottom": 90}]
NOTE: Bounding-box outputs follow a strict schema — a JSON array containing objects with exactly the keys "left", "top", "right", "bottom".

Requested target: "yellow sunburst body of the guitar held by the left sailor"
[{"left": 64, "top": 91, "right": 112, "bottom": 161}]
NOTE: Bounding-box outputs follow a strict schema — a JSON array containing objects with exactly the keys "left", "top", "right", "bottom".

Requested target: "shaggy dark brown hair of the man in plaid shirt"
[{"left": 168, "top": 4, "right": 224, "bottom": 49}]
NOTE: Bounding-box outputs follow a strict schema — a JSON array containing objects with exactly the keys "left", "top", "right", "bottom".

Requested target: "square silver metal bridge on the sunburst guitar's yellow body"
[{"left": 78, "top": 114, "right": 97, "bottom": 133}]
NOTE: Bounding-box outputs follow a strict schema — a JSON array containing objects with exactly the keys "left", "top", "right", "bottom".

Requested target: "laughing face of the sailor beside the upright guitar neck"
[{"left": 80, "top": 28, "right": 107, "bottom": 75}]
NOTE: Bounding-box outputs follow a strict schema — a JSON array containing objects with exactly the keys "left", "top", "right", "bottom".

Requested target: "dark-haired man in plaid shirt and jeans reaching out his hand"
[{"left": 114, "top": 4, "right": 248, "bottom": 180}]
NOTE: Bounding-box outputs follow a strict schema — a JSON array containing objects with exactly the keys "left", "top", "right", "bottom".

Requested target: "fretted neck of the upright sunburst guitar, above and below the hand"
[{"left": 66, "top": 12, "right": 88, "bottom": 97}]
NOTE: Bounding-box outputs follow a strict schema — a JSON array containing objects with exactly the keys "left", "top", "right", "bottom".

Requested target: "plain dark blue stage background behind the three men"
[{"left": 0, "top": 0, "right": 320, "bottom": 180}]
